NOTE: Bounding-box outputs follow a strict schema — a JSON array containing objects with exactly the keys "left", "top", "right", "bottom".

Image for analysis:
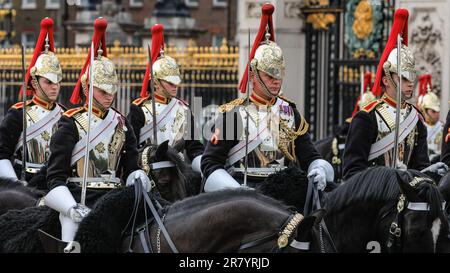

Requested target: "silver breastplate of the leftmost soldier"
[{"left": 17, "top": 105, "right": 58, "bottom": 164}]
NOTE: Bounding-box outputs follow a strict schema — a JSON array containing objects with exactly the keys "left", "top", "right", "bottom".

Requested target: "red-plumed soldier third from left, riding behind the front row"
[{"left": 128, "top": 24, "right": 204, "bottom": 173}]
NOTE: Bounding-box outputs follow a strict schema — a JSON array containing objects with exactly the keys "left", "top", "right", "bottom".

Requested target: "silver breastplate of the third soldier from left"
[{"left": 141, "top": 98, "right": 189, "bottom": 146}]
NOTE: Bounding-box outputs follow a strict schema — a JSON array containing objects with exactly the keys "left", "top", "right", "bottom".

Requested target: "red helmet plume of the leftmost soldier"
[{"left": 19, "top": 17, "right": 55, "bottom": 96}]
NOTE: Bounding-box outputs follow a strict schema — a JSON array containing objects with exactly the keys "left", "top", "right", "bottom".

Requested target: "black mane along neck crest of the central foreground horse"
[{"left": 169, "top": 189, "right": 290, "bottom": 213}]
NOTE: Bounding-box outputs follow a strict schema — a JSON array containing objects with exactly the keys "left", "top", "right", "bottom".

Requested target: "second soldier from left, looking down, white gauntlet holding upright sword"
[{"left": 45, "top": 18, "right": 150, "bottom": 242}]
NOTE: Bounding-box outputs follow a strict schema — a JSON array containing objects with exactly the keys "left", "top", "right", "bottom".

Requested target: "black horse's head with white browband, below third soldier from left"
[{"left": 140, "top": 141, "right": 187, "bottom": 202}]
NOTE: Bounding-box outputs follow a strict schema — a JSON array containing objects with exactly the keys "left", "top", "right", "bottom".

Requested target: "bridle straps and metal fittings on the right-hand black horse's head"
[{"left": 381, "top": 177, "right": 445, "bottom": 252}]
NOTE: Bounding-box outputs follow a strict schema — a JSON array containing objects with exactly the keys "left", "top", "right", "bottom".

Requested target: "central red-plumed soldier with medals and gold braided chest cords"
[{"left": 202, "top": 4, "right": 334, "bottom": 192}]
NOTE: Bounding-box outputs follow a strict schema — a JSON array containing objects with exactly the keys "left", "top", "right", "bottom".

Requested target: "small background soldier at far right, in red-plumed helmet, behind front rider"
[{"left": 417, "top": 74, "right": 444, "bottom": 162}]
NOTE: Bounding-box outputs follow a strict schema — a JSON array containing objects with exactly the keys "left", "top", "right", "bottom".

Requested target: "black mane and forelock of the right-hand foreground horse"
[{"left": 325, "top": 167, "right": 442, "bottom": 220}]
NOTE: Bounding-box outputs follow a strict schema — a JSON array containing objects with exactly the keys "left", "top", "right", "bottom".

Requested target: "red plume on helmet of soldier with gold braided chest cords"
[{"left": 239, "top": 3, "right": 275, "bottom": 93}]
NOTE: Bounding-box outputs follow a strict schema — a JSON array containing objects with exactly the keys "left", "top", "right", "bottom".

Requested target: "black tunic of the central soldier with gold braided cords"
[{"left": 201, "top": 103, "right": 322, "bottom": 186}]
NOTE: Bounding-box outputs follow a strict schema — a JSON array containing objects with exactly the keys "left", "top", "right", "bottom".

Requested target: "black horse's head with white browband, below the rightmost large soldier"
[{"left": 384, "top": 171, "right": 448, "bottom": 252}]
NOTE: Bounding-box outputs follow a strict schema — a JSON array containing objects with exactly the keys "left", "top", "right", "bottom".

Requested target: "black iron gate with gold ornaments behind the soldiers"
[{"left": 302, "top": 0, "right": 395, "bottom": 140}]
